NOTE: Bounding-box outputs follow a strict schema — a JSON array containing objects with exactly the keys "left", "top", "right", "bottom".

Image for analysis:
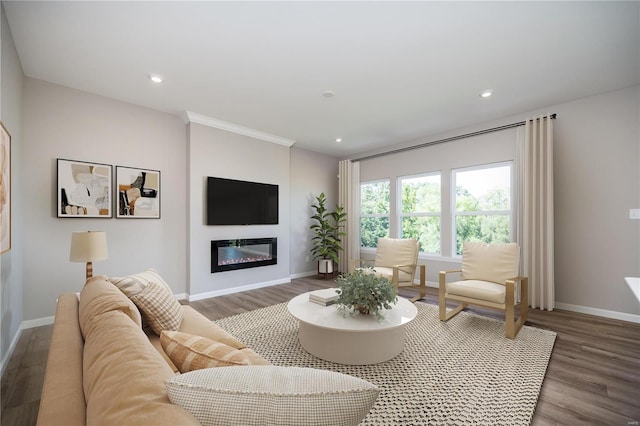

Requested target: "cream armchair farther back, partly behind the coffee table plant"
[{"left": 352, "top": 238, "right": 427, "bottom": 302}]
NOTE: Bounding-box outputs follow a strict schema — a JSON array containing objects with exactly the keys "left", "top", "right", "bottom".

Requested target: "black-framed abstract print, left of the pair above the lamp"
[{"left": 56, "top": 158, "right": 113, "bottom": 219}]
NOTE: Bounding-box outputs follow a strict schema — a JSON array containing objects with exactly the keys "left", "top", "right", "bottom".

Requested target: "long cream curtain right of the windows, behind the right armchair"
[{"left": 516, "top": 115, "right": 555, "bottom": 311}]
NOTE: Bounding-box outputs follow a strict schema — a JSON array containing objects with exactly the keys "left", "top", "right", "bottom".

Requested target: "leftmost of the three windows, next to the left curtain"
[{"left": 360, "top": 180, "right": 391, "bottom": 248}]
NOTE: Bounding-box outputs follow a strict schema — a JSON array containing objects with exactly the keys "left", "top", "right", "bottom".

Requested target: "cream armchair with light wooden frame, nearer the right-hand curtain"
[{"left": 439, "top": 242, "right": 529, "bottom": 339}]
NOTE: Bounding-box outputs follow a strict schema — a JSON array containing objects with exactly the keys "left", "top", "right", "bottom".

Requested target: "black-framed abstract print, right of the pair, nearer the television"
[{"left": 114, "top": 166, "right": 161, "bottom": 219}]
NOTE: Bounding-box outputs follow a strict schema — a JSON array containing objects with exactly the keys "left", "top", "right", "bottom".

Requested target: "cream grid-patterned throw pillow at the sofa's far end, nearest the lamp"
[{"left": 130, "top": 282, "right": 182, "bottom": 335}]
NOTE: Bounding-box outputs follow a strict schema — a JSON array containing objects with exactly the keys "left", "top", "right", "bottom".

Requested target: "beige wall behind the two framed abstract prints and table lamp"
[{"left": 18, "top": 78, "right": 188, "bottom": 320}]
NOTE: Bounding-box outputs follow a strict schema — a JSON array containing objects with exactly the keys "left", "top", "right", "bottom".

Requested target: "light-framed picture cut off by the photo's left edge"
[{"left": 0, "top": 121, "right": 11, "bottom": 254}]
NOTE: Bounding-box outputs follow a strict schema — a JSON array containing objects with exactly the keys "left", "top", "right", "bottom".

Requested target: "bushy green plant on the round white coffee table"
[{"left": 336, "top": 268, "right": 398, "bottom": 319}]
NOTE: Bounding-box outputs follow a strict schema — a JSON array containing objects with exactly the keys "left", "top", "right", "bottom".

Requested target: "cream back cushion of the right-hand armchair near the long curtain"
[{"left": 461, "top": 242, "right": 520, "bottom": 284}]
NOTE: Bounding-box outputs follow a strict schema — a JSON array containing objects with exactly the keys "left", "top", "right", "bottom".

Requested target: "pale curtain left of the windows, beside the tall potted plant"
[{"left": 338, "top": 160, "right": 360, "bottom": 272}]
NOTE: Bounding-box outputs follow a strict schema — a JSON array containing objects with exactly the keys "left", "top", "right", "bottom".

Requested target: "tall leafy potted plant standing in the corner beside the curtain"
[{"left": 309, "top": 192, "right": 347, "bottom": 274}]
